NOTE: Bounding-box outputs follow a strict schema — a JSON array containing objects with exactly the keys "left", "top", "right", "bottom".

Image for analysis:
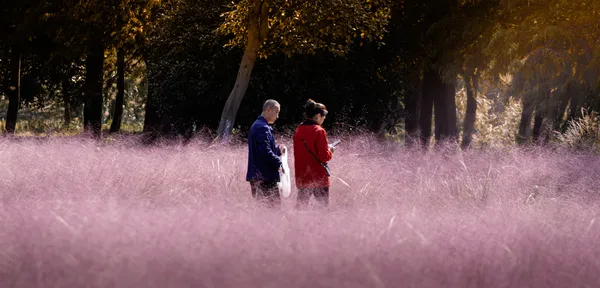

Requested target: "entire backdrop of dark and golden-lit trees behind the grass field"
[{"left": 0, "top": 0, "right": 600, "bottom": 147}]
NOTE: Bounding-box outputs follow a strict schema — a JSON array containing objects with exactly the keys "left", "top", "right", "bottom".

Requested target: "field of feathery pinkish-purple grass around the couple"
[{"left": 0, "top": 138, "right": 600, "bottom": 287}]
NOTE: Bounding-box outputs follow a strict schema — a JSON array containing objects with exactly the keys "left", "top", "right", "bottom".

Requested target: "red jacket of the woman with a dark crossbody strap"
[{"left": 294, "top": 119, "right": 332, "bottom": 189}]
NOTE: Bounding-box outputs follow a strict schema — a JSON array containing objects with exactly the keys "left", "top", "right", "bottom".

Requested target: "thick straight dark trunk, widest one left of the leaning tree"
[{"left": 83, "top": 31, "right": 104, "bottom": 139}]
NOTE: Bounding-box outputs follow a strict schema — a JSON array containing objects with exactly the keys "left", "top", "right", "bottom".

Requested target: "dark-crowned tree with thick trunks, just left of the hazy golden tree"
[{"left": 392, "top": 1, "right": 499, "bottom": 147}]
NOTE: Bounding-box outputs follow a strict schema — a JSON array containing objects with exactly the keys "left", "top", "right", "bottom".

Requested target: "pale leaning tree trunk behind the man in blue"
[{"left": 217, "top": 0, "right": 269, "bottom": 141}]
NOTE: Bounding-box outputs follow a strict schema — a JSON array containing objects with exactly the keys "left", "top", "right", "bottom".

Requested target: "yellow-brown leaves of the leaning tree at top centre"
[{"left": 218, "top": 0, "right": 392, "bottom": 57}]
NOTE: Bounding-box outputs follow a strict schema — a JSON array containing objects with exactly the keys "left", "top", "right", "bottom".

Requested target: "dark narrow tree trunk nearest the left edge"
[{"left": 5, "top": 51, "right": 21, "bottom": 135}]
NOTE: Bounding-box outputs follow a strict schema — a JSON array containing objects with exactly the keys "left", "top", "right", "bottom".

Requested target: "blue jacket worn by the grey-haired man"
[{"left": 246, "top": 116, "right": 281, "bottom": 182}]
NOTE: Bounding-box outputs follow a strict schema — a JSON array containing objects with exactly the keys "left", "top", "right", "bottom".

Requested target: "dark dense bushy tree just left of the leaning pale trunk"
[{"left": 138, "top": 0, "right": 233, "bottom": 142}]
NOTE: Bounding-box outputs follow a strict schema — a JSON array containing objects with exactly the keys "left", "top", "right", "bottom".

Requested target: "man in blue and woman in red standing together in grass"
[{"left": 246, "top": 99, "right": 335, "bottom": 209}]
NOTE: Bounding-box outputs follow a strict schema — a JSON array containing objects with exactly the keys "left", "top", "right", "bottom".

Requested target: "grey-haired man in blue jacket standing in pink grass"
[{"left": 246, "top": 99, "right": 289, "bottom": 208}]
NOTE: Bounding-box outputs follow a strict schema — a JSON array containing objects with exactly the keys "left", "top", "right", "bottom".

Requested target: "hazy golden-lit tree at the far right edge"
[{"left": 485, "top": 0, "right": 600, "bottom": 143}]
